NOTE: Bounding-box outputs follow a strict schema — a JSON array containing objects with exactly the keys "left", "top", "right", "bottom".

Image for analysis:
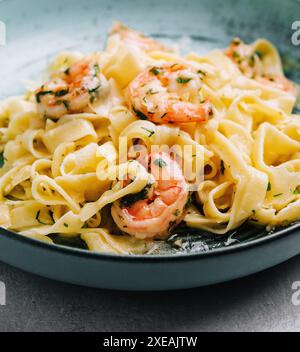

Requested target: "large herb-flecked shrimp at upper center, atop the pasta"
[{"left": 129, "top": 63, "right": 213, "bottom": 124}]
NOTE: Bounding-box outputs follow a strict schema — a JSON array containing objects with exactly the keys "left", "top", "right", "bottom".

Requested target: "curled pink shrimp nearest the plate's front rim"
[{"left": 112, "top": 153, "right": 189, "bottom": 239}]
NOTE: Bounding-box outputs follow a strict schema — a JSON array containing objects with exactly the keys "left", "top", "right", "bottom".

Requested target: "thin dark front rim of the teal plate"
[{"left": 0, "top": 222, "right": 300, "bottom": 263}]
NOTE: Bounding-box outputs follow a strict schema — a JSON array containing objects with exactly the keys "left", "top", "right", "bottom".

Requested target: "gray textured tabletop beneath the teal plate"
[{"left": 0, "top": 256, "right": 300, "bottom": 332}]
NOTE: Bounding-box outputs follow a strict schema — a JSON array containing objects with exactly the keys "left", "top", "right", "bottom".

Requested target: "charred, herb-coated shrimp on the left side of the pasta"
[{"left": 35, "top": 57, "right": 106, "bottom": 119}]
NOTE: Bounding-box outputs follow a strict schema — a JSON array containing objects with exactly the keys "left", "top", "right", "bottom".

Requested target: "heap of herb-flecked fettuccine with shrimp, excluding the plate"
[{"left": 0, "top": 23, "right": 300, "bottom": 254}]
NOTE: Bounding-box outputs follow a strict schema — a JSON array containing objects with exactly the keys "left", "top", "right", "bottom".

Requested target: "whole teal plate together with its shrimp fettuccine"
[{"left": 0, "top": 0, "right": 300, "bottom": 290}]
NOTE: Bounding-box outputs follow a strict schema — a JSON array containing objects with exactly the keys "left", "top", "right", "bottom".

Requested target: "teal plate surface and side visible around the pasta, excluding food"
[{"left": 0, "top": 0, "right": 300, "bottom": 290}]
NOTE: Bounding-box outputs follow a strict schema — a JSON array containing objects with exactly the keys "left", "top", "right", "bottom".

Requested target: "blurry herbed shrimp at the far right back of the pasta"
[{"left": 225, "top": 38, "right": 298, "bottom": 96}]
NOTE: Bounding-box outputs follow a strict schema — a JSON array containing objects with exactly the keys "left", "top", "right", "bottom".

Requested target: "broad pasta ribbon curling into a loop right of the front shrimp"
[{"left": 184, "top": 132, "right": 268, "bottom": 234}]
